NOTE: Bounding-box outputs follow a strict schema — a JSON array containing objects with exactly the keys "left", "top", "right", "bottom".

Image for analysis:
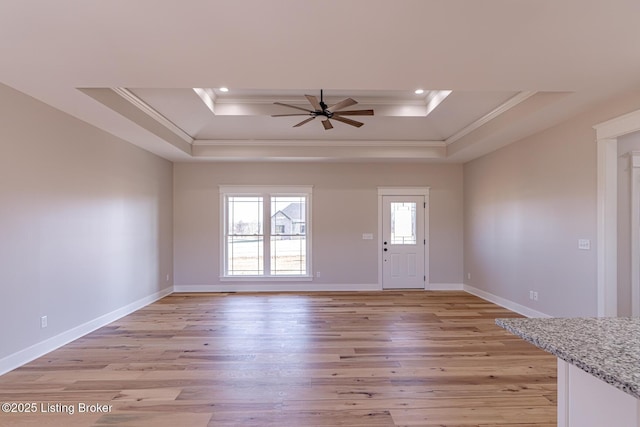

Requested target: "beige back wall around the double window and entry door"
[{"left": 174, "top": 163, "right": 462, "bottom": 289}]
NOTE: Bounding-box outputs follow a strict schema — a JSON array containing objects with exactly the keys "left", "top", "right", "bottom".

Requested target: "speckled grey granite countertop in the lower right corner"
[{"left": 496, "top": 317, "right": 640, "bottom": 399}]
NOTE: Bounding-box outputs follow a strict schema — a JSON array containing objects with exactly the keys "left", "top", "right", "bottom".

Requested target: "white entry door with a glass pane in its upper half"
[{"left": 381, "top": 196, "right": 426, "bottom": 289}]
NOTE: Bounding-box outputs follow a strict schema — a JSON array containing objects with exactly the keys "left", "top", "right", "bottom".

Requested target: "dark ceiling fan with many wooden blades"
[{"left": 271, "top": 89, "right": 373, "bottom": 130}]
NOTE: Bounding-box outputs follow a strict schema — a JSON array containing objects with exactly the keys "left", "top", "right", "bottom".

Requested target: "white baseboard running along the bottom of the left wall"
[{"left": 0, "top": 287, "right": 173, "bottom": 375}]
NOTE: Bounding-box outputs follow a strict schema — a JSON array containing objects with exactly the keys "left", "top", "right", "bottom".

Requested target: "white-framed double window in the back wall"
[{"left": 220, "top": 186, "right": 312, "bottom": 280}]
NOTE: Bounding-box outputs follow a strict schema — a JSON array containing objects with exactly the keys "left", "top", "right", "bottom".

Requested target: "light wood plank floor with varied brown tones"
[{"left": 0, "top": 291, "right": 556, "bottom": 427}]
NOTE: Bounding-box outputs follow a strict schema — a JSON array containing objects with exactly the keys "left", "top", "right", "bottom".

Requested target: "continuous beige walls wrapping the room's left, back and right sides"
[{"left": 0, "top": 74, "right": 640, "bottom": 372}]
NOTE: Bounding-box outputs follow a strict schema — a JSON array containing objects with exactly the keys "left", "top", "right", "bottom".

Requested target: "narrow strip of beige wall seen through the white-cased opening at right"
[{"left": 618, "top": 132, "right": 640, "bottom": 316}]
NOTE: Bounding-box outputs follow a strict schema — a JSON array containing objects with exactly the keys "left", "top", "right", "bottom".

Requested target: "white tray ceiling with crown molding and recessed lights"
[{"left": 0, "top": 0, "right": 640, "bottom": 162}]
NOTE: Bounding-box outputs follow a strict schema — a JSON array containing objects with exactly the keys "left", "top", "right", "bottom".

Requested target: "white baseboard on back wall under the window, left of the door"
[{"left": 173, "top": 282, "right": 382, "bottom": 292}]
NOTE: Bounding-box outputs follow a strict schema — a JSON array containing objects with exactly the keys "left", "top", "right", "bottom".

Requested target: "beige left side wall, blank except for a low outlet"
[{"left": 0, "top": 85, "right": 173, "bottom": 362}]
